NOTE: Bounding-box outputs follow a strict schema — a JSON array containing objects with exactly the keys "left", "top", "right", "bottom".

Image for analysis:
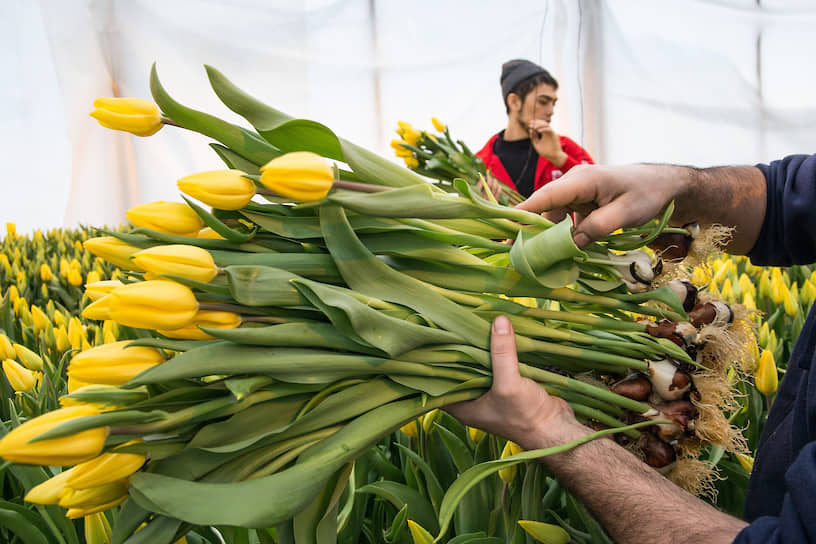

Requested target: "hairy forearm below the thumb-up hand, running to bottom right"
[{"left": 523, "top": 423, "right": 746, "bottom": 544}]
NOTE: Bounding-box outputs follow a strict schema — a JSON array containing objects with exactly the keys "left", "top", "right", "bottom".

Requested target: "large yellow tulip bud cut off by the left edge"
[{"left": 0, "top": 406, "right": 108, "bottom": 466}]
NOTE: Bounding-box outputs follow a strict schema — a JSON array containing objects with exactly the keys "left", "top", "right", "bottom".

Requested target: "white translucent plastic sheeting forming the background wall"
[{"left": 0, "top": 0, "right": 816, "bottom": 236}]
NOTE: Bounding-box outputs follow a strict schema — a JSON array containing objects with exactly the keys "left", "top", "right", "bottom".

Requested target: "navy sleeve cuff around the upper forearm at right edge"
[{"left": 748, "top": 155, "right": 816, "bottom": 266}]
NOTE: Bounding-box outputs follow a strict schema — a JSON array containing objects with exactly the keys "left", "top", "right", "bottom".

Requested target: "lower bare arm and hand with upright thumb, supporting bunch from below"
[{"left": 446, "top": 316, "right": 746, "bottom": 544}]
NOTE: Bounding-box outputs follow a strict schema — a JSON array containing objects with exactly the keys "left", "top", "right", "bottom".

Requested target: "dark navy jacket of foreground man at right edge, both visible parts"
[{"left": 734, "top": 155, "right": 816, "bottom": 544}]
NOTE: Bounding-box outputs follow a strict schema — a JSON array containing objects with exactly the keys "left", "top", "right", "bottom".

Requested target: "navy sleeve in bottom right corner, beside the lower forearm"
[{"left": 734, "top": 442, "right": 816, "bottom": 544}]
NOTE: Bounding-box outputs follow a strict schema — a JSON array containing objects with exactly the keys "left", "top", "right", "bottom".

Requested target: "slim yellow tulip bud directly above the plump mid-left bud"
[{"left": 131, "top": 244, "right": 218, "bottom": 283}]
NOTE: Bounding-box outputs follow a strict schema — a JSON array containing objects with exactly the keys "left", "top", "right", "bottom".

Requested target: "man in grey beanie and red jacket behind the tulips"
[{"left": 476, "top": 59, "right": 593, "bottom": 198}]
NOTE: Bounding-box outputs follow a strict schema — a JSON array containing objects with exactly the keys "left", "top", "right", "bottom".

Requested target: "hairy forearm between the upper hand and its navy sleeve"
[{"left": 658, "top": 166, "right": 767, "bottom": 255}]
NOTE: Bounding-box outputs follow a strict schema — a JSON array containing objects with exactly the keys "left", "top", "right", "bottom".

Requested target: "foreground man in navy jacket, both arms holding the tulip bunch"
[{"left": 446, "top": 155, "right": 816, "bottom": 544}]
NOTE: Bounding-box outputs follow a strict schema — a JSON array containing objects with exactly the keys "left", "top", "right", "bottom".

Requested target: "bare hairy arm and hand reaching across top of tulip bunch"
[{"left": 518, "top": 164, "right": 767, "bottom": 254}]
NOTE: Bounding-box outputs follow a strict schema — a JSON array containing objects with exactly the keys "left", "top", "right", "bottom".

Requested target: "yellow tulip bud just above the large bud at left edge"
[{"left": 68, "top": 340, "right": 164, "bottom": 385}]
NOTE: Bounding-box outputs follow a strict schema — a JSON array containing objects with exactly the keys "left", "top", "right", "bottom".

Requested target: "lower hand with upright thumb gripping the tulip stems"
[{"left": 445, "top": 316, "right": 590, "bottom": 450}]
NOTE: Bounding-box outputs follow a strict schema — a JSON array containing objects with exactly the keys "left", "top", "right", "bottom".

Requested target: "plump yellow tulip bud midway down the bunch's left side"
[{"left": 101, "top": 280, "right": 198, "bottom": 330}]
